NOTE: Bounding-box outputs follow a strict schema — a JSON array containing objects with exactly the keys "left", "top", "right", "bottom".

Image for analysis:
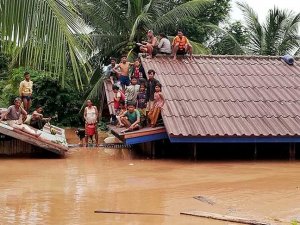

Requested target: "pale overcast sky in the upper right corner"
[{"left": 231, "top": 0, "right": 300, "bottom": 22}]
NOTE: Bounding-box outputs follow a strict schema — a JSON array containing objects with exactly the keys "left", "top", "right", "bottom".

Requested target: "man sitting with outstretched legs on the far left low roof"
[{"left": 0, "top": 98, "right": 41, "bottom": 137}]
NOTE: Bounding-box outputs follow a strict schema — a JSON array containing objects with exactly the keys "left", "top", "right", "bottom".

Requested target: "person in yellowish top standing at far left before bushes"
[{"left": 19, "top": 72, "right": 33, "bottom": 112}]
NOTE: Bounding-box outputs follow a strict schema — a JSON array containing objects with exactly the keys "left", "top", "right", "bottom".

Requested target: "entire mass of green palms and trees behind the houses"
[{"left": 0, "top": 0, "right": 300, "bottom": 126}]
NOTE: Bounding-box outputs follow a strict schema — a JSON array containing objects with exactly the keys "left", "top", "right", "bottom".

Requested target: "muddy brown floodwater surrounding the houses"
[{"left": 0, "top": 129, "right": 300, "bottom": 225}]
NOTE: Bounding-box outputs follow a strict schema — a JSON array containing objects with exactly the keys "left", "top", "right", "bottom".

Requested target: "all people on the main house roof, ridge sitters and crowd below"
[{"left": 106, "top": 30, "right": 193, "bottom": 132}]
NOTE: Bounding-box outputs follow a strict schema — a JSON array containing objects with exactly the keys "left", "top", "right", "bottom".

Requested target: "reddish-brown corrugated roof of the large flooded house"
[{"left": 142, "top": 56, "right": 300, "bottom": 137}]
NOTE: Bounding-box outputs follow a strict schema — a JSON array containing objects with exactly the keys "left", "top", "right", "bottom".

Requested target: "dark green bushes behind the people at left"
[{"left": 1, "top": 67, "right": 83, "bottom": 126}]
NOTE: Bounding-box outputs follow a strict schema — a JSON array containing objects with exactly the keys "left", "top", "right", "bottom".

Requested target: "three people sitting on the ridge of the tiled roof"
[{"left": 137, "top": 30, "right": 193, "bottom": 59}]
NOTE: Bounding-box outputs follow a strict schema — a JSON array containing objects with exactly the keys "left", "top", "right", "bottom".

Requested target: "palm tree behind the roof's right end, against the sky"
[{"left": 237, "top": 2, "right": 300, "bottom": 55}]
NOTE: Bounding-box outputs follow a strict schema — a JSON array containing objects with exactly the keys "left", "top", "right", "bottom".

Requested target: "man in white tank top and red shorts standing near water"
[{"left": 84, "top": 100, "right": 99, "bottom": 147}]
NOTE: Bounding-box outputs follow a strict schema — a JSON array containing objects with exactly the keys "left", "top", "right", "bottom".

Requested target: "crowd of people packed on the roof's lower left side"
[{"left": 106, "top": 56, "right": 165, "bottom": 132}]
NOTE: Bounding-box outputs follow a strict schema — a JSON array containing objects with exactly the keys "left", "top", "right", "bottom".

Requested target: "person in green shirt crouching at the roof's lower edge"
[{"left": 120, "top": 102, "right": 141, "bottom": 132}]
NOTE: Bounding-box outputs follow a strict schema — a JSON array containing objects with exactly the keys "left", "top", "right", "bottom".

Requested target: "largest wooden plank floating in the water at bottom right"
[{"left": 180, "top": 211, "right": 271, "bottom": 225}]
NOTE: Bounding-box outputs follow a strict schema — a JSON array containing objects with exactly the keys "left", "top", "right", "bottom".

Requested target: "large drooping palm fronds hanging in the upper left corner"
[{"left": 0, "top": 0, "right": 92, "bottom": 87}]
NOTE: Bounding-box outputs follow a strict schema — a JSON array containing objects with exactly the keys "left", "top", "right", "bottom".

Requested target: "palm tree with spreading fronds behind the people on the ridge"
[{"left": 78, "top": 0, "right": 209, "bottom": 58}]
